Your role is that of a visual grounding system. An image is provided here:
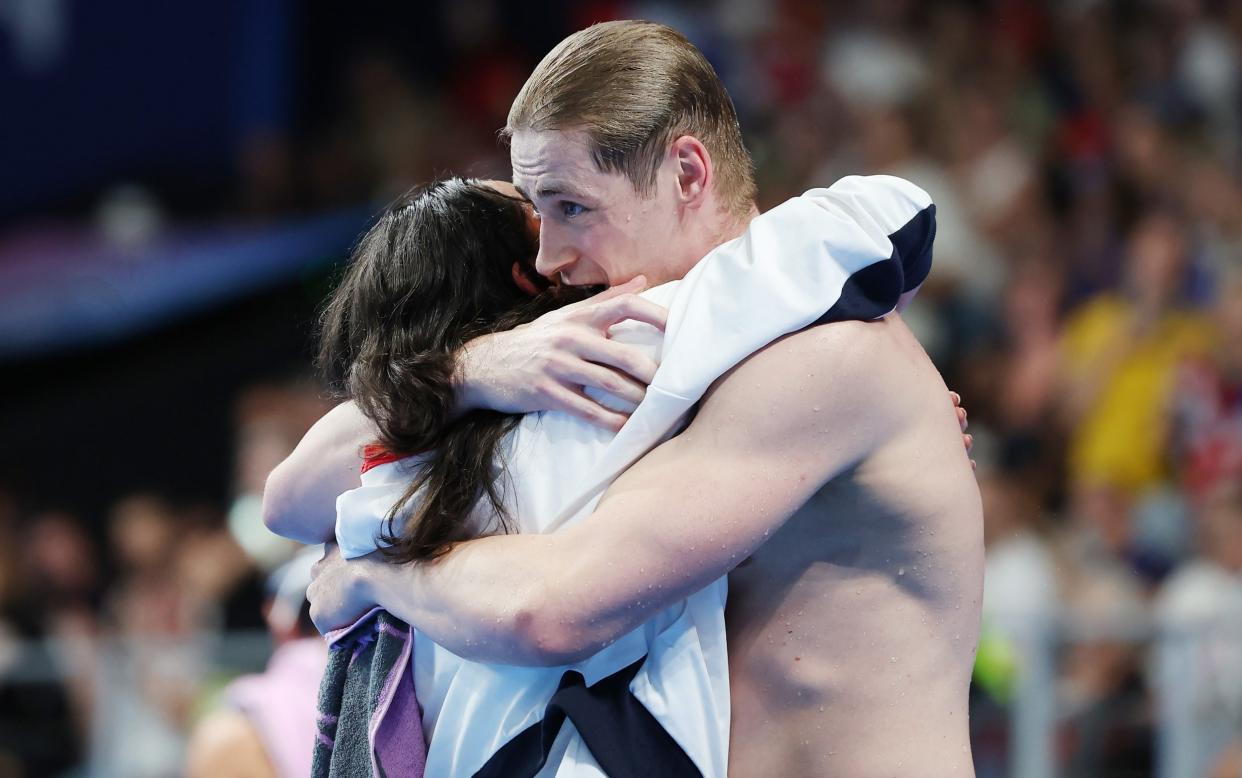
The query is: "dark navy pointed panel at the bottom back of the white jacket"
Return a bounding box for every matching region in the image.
[474,656,703,778]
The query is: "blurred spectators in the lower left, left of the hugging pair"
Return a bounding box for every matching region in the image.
[0,385,328,778]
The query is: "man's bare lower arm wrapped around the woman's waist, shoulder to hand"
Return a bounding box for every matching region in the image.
[311,322,914,665]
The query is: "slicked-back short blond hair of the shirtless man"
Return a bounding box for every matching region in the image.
[504,21,755,214]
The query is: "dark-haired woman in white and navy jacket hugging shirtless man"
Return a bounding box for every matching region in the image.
[288,176,930,777]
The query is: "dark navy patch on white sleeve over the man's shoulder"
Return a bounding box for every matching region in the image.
[815,204,935,324]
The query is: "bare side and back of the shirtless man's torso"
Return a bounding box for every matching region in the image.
[727,317,984,778]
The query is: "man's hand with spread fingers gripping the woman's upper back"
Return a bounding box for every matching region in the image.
[457,276,668,430]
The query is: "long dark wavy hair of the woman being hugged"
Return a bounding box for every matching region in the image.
[319,178,587,562]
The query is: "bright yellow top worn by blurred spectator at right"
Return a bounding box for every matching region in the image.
[1062,295,1211,493]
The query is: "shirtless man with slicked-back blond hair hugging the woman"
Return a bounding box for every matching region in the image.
[285,22,982,777]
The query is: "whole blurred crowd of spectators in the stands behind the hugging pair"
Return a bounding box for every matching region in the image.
[0,0,1242,777]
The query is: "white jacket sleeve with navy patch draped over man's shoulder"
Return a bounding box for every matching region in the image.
[652,175,935,401]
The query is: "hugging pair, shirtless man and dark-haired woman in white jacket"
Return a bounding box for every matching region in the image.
[265,22,982,778]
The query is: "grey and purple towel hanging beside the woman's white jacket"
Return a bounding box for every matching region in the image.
[311,608,427,778]
